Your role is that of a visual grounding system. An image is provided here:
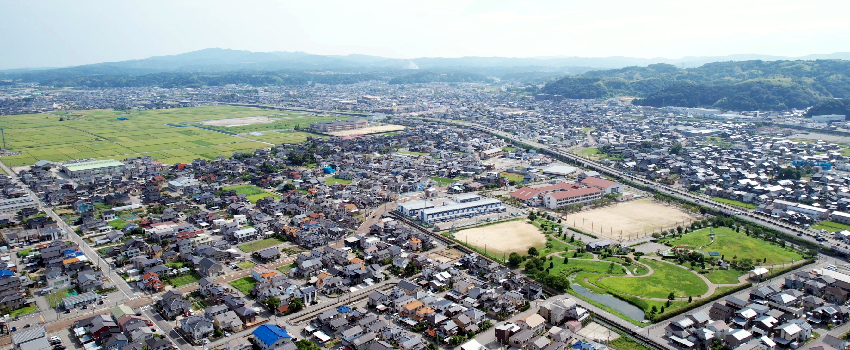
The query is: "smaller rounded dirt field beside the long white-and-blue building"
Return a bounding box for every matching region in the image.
[455,220,546,254]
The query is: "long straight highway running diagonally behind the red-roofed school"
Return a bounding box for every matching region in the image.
[416,117,850,255]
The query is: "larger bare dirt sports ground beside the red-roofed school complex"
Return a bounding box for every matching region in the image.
[566,199,692,239]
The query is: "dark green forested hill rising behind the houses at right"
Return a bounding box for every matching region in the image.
[543,60,850,110]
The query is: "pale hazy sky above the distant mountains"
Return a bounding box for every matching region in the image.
[0,0,850,69]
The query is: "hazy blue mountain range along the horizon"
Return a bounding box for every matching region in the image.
[0,48,850,75]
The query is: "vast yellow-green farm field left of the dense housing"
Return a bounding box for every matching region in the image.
[0,106,318,166]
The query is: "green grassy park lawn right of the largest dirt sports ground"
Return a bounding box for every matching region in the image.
[669,227,803,265]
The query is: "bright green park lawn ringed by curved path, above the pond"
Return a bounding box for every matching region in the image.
[598,259,708,298]
